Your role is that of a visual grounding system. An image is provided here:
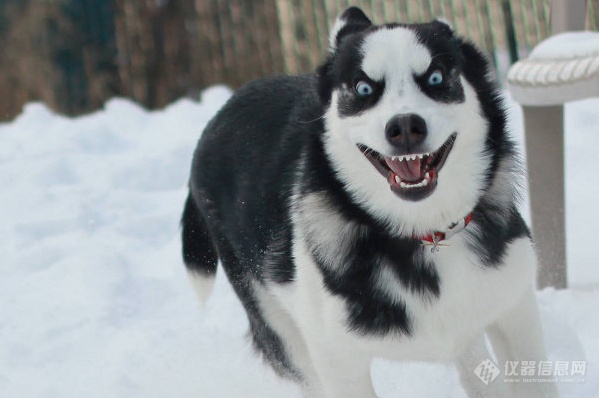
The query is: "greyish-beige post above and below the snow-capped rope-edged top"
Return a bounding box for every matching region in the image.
[523,0,587,289]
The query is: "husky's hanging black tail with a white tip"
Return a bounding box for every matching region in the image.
[181,193,219,307]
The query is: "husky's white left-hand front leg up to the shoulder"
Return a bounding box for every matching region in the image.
[260,215,375,398]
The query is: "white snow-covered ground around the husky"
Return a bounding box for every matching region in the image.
[0,87,598,398]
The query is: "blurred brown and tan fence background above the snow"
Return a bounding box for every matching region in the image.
[0,0,598,121]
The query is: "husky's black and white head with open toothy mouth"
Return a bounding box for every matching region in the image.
[317,7,510,233]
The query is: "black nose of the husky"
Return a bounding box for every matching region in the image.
[385,113,427,153]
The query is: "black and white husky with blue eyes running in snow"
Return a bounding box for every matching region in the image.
[182,8,556,398]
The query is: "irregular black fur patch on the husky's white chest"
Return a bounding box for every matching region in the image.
[313,226,440,336]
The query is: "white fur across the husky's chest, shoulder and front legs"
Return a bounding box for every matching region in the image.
[255,194,556,398]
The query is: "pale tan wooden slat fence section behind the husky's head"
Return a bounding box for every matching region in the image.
[278,0,549,73]
